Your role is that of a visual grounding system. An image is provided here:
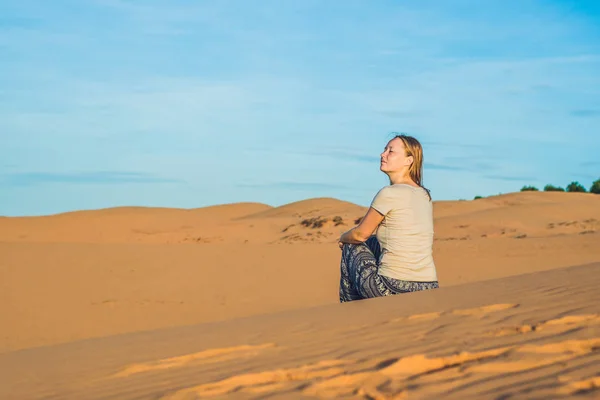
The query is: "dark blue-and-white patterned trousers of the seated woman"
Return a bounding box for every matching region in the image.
[340,236,439,303]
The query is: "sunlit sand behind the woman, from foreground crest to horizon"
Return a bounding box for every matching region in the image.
[0,193,600,352]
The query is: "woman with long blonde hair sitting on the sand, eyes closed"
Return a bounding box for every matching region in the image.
[339,135,439,303]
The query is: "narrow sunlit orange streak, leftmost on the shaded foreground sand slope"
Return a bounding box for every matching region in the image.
[113,343,275,378]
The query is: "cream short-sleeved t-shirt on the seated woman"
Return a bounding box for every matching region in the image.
[371,183,437,282]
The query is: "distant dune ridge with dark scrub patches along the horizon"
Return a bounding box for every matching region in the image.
[0,192,600,244]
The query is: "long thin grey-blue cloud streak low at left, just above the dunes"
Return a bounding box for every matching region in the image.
[0,171,183,186]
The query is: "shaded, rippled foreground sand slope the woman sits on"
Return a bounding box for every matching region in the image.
[0,264,600,400]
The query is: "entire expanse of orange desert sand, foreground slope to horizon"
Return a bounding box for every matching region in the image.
[0,192,600,399]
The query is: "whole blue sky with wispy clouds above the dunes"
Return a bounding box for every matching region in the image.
[0,0,600,215]
